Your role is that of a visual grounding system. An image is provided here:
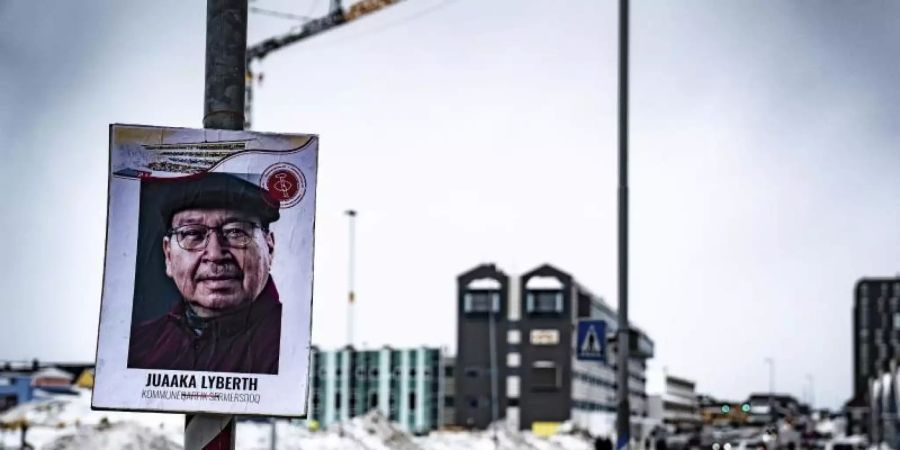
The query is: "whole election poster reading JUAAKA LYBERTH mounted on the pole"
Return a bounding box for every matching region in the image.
[91,124,318,417]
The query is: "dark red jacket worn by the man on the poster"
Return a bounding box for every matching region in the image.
[128,278,281,374]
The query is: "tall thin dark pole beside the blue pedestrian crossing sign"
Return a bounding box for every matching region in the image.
[616,0,631,449]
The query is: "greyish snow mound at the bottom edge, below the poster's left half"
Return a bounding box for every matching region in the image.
[41,422,182,450]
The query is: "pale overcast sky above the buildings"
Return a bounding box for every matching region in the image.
[0,0,900,407]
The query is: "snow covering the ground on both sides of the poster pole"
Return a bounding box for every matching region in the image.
[0,389,593,450]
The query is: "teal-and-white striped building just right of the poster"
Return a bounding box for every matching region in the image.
[309,347,443,433]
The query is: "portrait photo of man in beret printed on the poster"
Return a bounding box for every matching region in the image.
[128,172,282,374]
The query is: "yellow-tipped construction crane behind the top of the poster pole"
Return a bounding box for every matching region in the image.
[244,0,403,130]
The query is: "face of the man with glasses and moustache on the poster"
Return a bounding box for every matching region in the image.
[163,209,275,317]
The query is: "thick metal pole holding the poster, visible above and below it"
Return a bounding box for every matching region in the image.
[184,0,247,450]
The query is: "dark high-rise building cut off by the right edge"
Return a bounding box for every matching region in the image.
[845,276,900,434]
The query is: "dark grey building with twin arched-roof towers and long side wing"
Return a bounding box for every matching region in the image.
[455,265,653,436]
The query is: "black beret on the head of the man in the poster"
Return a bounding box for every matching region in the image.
[160,172,280,226]
